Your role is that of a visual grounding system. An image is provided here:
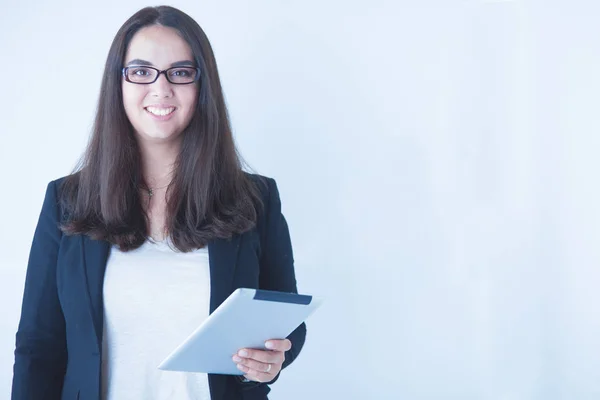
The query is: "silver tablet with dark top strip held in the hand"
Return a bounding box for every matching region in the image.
[158,289,322,375]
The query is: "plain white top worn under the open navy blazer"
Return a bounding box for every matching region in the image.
[102,241,210,400]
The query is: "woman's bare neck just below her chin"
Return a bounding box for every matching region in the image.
[139,141,180,188]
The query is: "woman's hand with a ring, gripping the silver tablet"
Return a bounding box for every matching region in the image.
[233,339,292,382]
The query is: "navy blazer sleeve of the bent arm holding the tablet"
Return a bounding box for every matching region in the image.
[259,178,306,383]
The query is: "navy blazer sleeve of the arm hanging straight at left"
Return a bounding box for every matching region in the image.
[12,182,67,400]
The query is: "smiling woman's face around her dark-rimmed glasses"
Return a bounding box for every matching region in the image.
[122,25,198,143]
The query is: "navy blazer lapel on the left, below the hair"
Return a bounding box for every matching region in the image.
[81,235,110,351]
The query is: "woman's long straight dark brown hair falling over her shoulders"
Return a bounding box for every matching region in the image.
[61,6,261,252]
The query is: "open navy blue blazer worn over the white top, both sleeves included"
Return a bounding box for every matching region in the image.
[12,175,306,400]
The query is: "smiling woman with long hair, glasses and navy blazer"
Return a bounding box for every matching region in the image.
[12,7,306,400]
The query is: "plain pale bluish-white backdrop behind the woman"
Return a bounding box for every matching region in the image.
[0,0,600,400]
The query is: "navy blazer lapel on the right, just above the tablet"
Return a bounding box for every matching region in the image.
[208,234,241,314]
